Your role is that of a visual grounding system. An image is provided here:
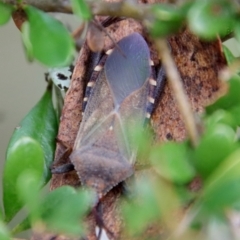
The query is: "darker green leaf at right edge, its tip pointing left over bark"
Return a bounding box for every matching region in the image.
[206,76,240,114]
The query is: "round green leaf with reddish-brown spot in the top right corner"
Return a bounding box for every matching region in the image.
[188,0,235,39]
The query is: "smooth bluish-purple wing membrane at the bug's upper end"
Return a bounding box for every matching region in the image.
[105,33,151,106]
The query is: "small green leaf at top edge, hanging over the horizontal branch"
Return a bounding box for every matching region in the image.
[71,0,92,21]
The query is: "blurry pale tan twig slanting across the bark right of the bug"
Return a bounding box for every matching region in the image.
[154,39,199,146]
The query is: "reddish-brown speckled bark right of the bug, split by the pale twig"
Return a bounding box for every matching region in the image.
[151,29,226,141]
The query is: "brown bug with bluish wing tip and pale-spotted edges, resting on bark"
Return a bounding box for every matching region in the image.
[67,33,164,198]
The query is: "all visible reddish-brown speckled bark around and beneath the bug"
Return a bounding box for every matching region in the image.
[33,1,226,240]
